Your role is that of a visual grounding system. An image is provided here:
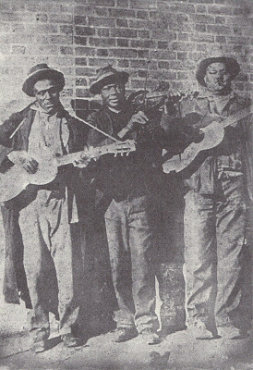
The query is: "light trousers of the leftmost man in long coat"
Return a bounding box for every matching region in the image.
[19,189,79,337]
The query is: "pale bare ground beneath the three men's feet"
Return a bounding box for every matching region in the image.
[0,303,253,370]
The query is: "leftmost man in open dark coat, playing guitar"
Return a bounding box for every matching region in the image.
[0,64,91,352]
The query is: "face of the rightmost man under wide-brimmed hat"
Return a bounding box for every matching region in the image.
[204,63,231,94]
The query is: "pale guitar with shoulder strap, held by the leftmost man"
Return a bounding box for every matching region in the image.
[0,140,136,202]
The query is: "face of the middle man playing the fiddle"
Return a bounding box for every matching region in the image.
[101,83,125,109]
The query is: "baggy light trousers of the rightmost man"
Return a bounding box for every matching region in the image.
[184,172,246,327]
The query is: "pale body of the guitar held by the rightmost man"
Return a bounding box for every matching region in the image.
[162,122,224,173]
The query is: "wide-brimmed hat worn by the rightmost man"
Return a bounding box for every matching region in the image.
[196,57,240,86]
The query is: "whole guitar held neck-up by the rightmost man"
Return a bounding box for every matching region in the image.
[162,104,253,173]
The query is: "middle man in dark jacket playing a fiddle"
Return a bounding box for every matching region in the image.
[88,66,197,344]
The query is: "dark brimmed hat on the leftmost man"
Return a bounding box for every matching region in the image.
[22,64,65,96]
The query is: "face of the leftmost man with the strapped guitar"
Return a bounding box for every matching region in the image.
[34,79,60,113]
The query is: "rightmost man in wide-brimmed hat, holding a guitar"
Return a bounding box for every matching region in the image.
[165,57,253,338]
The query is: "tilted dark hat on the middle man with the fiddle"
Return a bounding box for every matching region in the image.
[90,65,129,94]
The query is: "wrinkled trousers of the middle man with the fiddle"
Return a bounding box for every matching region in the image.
[105,196,158,333]
